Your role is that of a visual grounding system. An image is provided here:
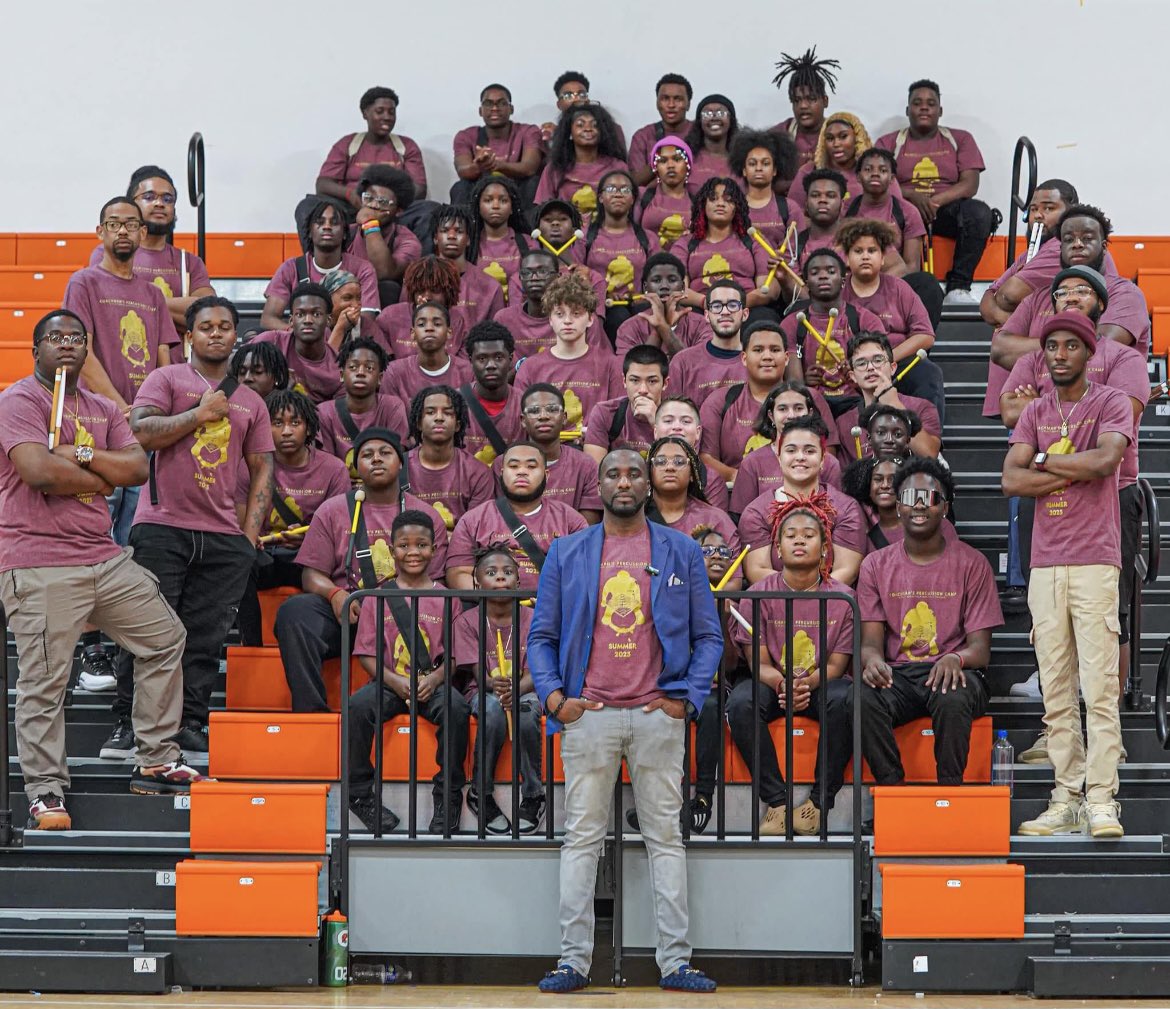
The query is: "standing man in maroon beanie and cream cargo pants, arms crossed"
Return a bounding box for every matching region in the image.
[1003,311,1134,837]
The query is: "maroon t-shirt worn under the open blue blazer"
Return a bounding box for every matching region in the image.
[581,528,663,718]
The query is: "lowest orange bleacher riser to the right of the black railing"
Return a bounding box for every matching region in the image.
[881,863,1024,939]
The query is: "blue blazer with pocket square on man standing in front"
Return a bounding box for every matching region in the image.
[528,522,723,733]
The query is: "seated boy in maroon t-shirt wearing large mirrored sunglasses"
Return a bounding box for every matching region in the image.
[849,458,1004,785]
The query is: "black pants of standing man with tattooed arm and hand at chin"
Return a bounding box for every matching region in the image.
[113,522,256,726]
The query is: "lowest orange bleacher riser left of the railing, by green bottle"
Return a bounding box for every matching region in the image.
[174,858,321,938]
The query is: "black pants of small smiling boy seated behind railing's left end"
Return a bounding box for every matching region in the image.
[350,684,472,800]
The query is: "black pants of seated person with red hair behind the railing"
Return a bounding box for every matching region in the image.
[728,677,853,812]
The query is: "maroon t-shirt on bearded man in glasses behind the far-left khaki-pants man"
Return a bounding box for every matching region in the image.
[61,266,179,403]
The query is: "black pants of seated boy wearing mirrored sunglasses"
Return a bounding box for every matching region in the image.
[849,663,987,784]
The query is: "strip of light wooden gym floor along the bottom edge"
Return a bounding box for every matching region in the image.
[0,984,1156,1009]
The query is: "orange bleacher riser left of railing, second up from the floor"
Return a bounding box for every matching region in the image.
[191,781,329,854]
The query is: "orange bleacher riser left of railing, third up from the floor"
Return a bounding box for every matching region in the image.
[208,712,342,781]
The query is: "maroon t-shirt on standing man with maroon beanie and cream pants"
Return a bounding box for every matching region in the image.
[1007,383,1134,568]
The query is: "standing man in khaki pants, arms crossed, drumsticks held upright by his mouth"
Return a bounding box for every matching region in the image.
[0,309,200,830]
